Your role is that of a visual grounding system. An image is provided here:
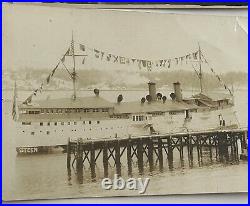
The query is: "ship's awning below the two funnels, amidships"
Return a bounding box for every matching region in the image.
[114,100,198,114]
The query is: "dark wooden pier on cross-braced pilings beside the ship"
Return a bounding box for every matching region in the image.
[67,129,247,180]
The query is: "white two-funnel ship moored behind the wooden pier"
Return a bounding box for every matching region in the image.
[13,37,239,154]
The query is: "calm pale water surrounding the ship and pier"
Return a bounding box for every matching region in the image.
[2,90,248,200]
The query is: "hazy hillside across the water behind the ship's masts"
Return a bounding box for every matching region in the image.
[2,69,247,90]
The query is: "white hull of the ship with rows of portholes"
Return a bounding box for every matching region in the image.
[16,107,238,151]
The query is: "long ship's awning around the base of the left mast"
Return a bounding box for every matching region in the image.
[20,96,113,109]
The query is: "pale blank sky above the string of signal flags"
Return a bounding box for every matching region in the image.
[2,4,248,73]
